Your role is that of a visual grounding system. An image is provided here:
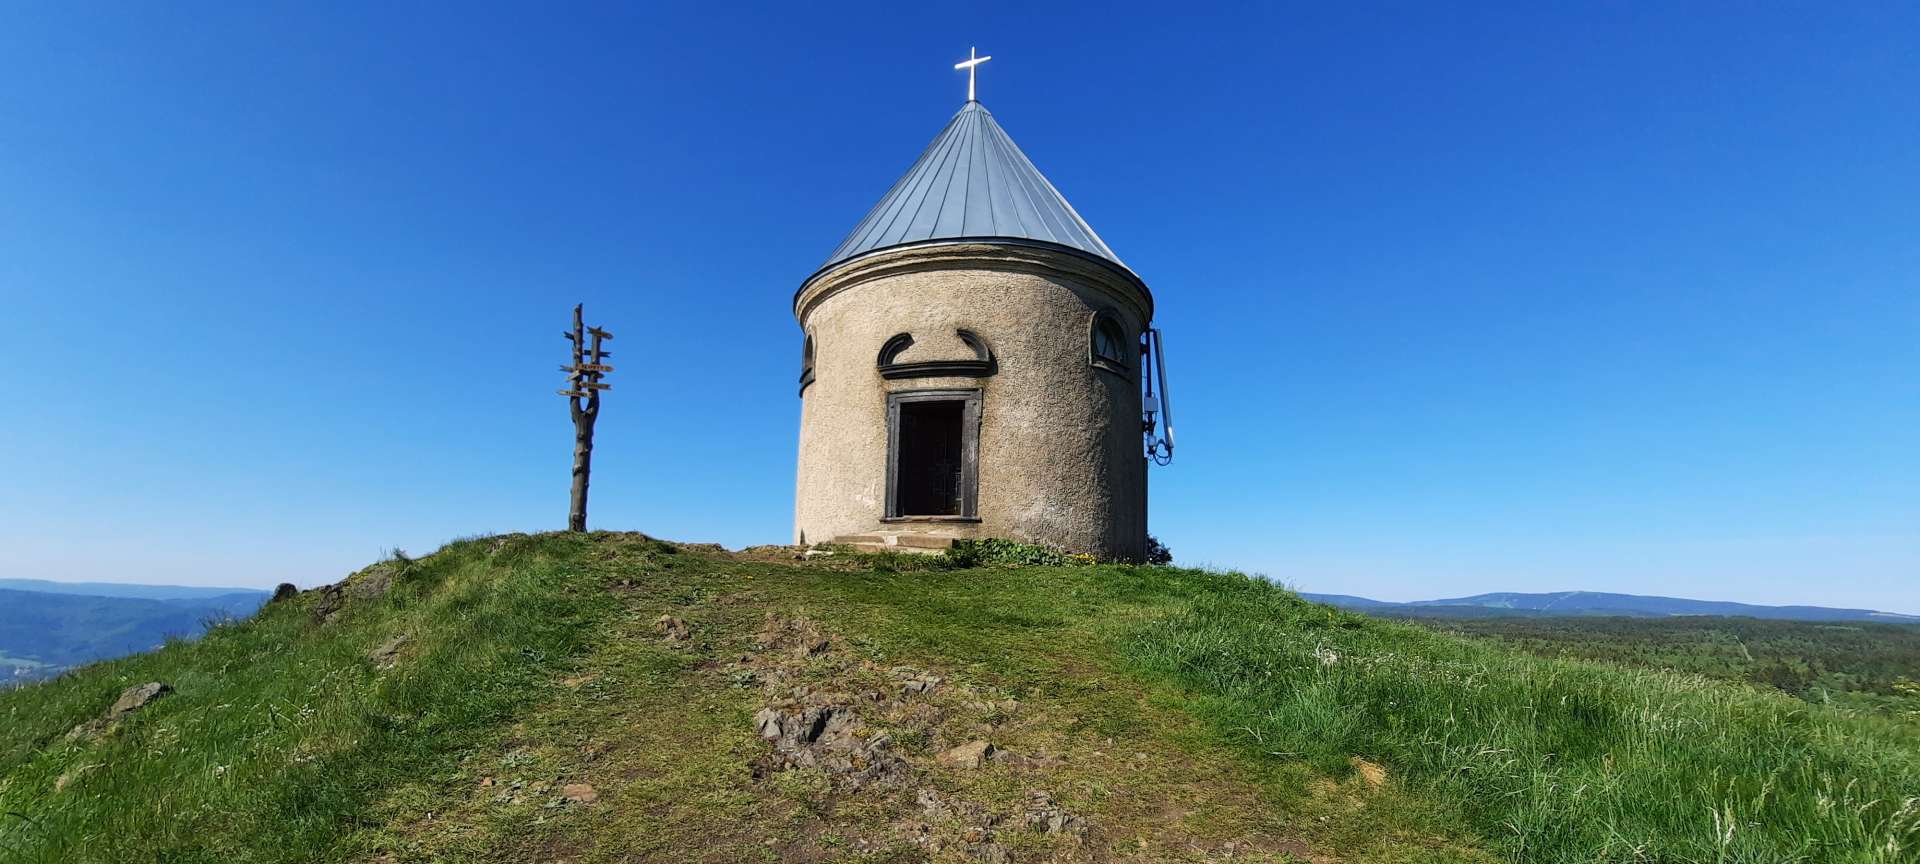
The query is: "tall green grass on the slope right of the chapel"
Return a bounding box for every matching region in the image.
[1129,572,1920,864]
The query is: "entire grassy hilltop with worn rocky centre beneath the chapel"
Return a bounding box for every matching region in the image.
[0,534,1920,862]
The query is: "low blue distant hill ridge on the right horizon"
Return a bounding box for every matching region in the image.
[1302,591,1920,624]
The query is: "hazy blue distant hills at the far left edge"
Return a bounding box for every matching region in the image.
[0,580,269,685]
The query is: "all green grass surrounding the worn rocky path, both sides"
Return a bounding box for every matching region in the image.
[0,534,1920,864]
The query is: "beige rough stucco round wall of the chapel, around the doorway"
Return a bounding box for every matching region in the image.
[795,246,1146,559]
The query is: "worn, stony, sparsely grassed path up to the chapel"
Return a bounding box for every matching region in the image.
[360,543,1443,864]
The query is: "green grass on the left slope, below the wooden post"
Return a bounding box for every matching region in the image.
[0,536,611,862]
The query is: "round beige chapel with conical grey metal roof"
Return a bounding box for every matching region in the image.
[793,81,1164,561]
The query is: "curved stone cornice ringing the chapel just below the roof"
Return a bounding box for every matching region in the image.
[793,240,1154,324]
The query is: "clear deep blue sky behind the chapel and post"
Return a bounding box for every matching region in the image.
[0,4,1920,612]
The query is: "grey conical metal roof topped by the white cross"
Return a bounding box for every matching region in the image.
[820,102,1133,275]
